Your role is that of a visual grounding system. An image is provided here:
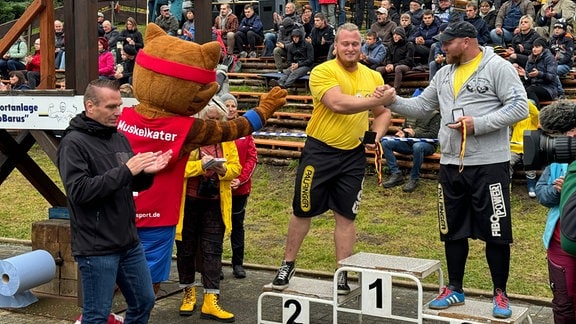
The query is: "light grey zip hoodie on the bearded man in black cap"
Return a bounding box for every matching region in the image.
[389,47,528,165]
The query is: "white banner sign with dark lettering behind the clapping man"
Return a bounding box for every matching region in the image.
[0,95,137,130]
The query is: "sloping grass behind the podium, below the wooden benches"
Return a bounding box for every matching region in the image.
[0,146,551,297]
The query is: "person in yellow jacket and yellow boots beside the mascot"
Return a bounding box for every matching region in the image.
[176,99,242,322]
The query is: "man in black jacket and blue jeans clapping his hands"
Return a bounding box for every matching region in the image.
[58,80,172,323]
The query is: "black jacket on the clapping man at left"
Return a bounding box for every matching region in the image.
[58,112,154,256]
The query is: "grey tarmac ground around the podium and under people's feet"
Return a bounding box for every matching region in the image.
[0,243,554,324]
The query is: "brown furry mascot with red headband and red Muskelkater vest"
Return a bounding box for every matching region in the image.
[118,23,287,306]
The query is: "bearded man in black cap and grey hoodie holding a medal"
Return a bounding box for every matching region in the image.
[382,22,528,318]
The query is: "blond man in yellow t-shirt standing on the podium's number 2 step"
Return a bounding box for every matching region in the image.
[272,23,396,294]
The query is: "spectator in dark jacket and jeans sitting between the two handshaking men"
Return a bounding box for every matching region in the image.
[382,111,441,192]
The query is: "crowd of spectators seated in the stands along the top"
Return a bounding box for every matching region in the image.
[0,0,576,101]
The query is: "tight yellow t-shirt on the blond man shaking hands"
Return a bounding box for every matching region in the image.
[306,59,384,150]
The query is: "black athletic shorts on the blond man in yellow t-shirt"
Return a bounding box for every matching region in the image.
[292,137,366,220]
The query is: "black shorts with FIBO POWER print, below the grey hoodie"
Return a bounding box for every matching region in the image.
[438,162,512,243]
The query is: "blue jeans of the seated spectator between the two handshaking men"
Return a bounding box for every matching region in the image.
[382,140,436,180]
